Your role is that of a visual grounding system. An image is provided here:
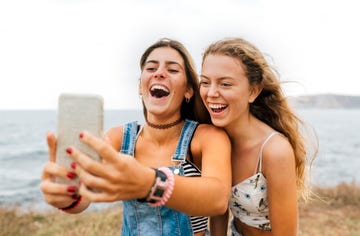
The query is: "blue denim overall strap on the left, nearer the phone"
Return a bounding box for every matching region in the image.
[120,121,139,156]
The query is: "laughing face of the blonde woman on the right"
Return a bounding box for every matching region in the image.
[200,54,257,128]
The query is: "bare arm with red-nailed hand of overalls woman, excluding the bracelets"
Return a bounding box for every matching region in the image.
[70,125,231,215]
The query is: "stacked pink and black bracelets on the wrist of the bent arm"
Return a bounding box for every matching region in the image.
[146,167,175,207]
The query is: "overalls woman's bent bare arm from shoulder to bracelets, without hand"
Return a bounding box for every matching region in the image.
[167,125,231,215]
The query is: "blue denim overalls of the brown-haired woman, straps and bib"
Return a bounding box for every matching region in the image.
[121,120,197,236]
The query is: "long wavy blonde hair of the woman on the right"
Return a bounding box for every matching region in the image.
[203,38,317,200]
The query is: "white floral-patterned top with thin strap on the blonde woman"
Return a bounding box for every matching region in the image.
[229,131,279,231]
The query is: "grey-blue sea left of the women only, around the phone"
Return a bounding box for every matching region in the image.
[0,110,144,209]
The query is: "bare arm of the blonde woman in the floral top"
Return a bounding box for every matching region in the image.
[263,136,298,235]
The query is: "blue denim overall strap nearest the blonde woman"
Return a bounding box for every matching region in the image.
[171,119,198,162]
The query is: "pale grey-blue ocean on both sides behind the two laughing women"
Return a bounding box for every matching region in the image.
[0,109,360,206]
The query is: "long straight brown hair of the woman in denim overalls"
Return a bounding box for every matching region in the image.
[140,38,211,124]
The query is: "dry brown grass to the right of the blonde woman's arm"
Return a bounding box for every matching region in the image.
[299,183,360,236]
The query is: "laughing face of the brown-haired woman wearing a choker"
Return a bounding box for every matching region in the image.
[139,47,192,120]
